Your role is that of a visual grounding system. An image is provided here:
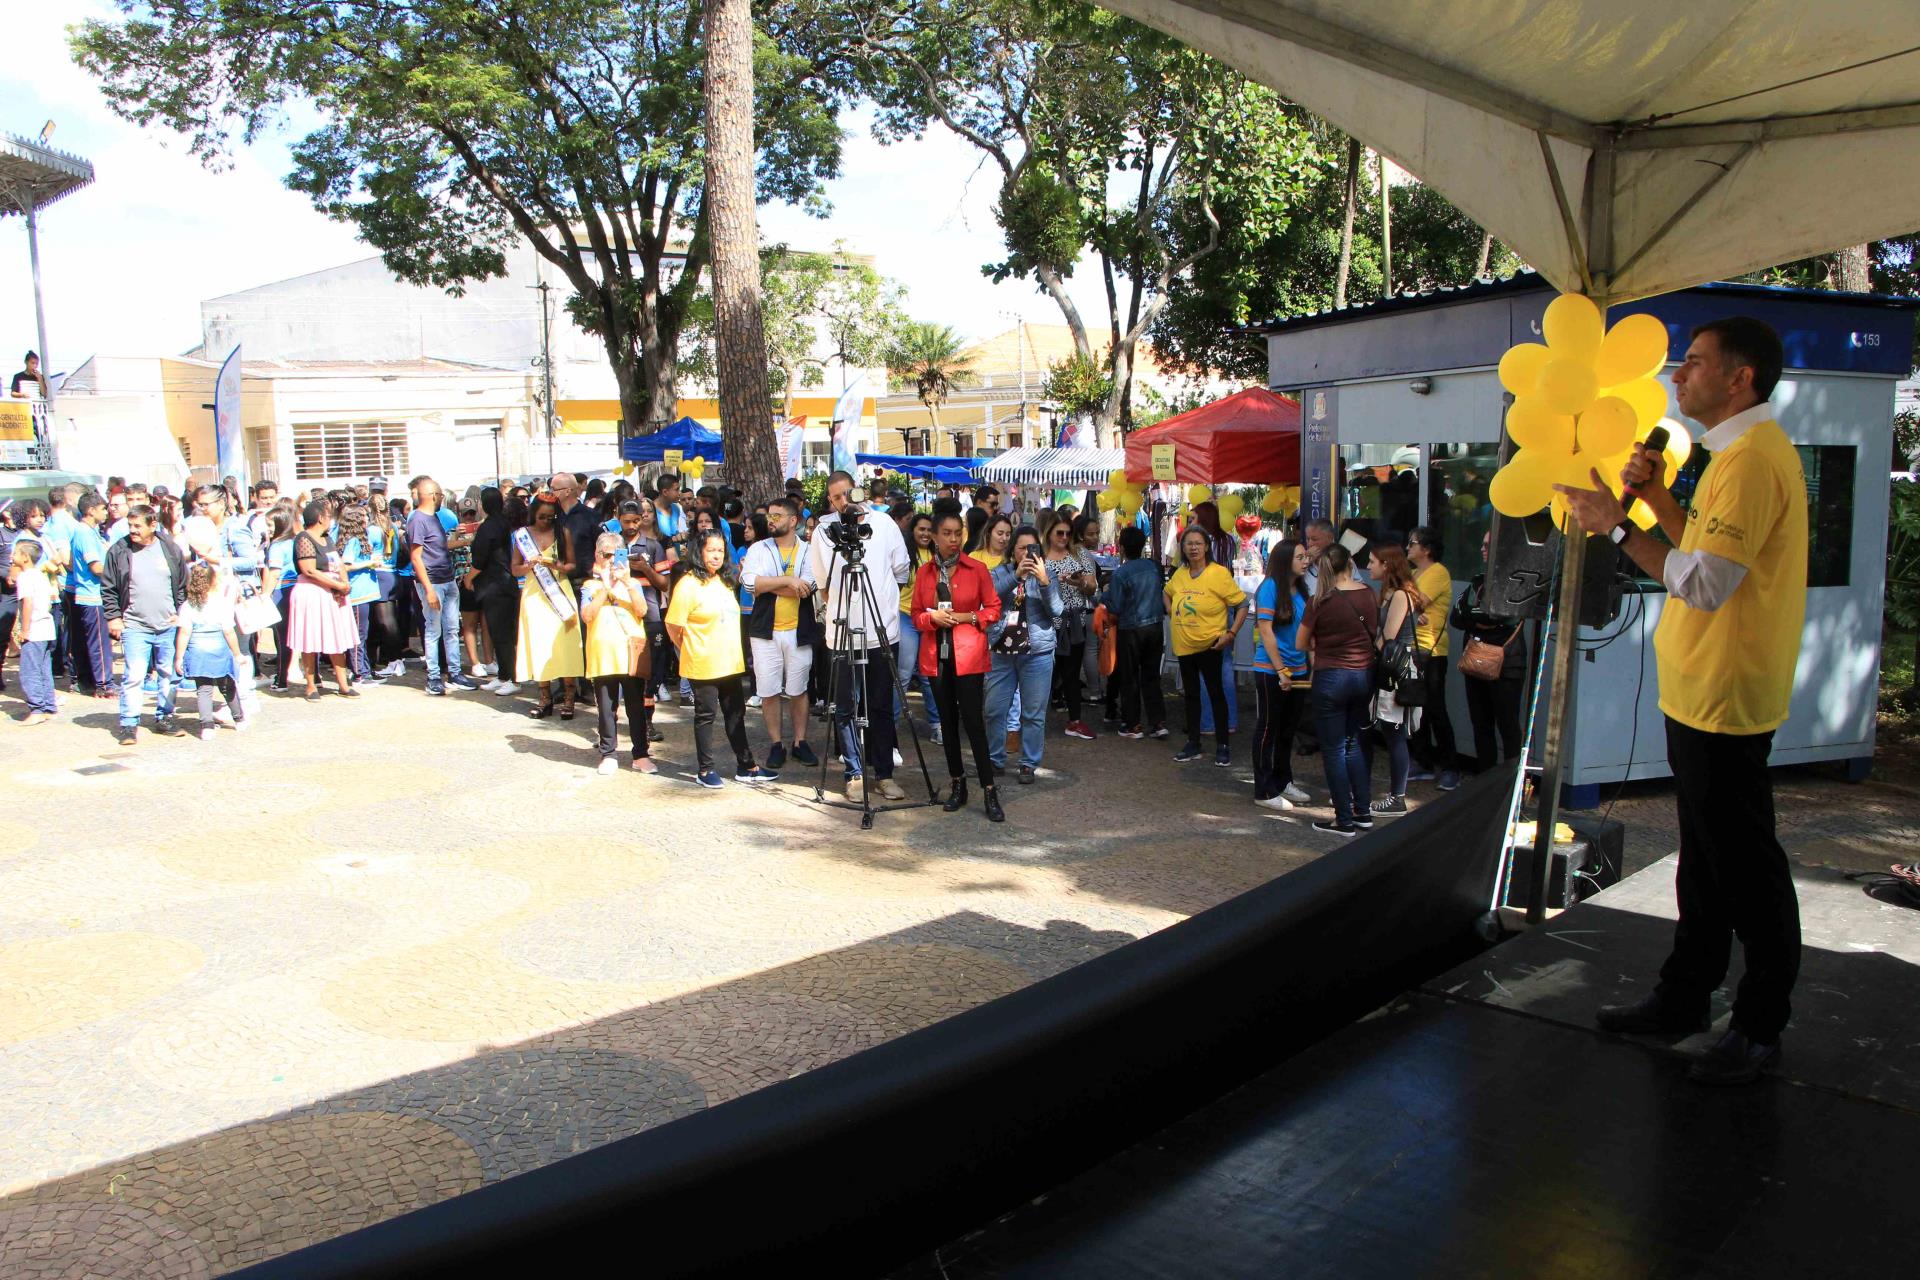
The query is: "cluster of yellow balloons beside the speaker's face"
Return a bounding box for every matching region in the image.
[1488,294,1693,528]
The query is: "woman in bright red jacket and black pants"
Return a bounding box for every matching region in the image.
[912,497,1006,821]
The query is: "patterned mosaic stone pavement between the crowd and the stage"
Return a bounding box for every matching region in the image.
[0,687,1912,1278]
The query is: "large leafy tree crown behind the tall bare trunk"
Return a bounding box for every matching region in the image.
[71,0,860,429]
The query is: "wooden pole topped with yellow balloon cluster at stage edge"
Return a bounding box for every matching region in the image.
[1488,294,1693,925]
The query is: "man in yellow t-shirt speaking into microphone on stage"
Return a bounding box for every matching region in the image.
[1559,317,1807,1084]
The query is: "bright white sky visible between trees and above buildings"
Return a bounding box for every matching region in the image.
[0,0,1106,370]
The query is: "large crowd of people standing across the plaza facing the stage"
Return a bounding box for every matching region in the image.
[0,472,1528,835]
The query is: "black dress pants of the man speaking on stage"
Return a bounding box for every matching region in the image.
[1659,720,1801,1044]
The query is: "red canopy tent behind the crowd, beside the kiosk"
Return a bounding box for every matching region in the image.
[1127,388,1300,484]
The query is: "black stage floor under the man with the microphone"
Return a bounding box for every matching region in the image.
[899,860,1920,1280]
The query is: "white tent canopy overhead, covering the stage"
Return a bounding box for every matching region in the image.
[1102,0,1920,301]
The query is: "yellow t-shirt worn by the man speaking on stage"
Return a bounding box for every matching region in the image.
[1653,420,1807,733]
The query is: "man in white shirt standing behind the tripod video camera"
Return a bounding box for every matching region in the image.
[808,470,910,802]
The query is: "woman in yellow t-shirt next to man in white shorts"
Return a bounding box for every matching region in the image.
[664,528,780,791]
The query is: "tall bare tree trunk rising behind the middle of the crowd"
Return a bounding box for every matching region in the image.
[705,0,781,503]
